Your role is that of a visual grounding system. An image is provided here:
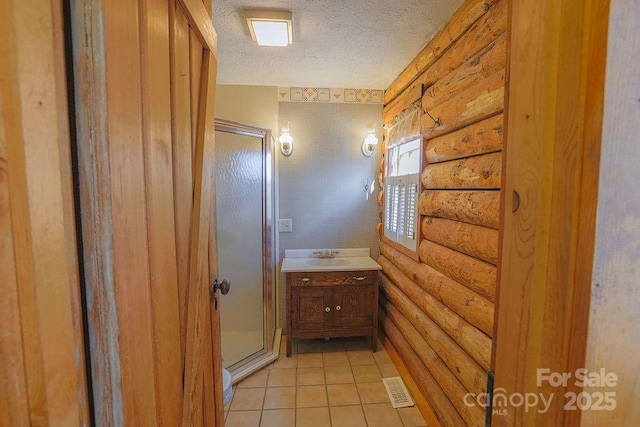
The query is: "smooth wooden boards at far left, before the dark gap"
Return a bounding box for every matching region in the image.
[0,0,90,426]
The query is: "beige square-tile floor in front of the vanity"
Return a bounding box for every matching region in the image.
[225,338,426,427]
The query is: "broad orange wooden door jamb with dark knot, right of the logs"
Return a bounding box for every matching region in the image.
[493,0,608,426]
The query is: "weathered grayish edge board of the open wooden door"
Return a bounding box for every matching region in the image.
[71,2,124,425]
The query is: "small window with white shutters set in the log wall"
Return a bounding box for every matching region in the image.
[384,137,422,251]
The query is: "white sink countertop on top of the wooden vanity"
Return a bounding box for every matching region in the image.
[281,248,382,273]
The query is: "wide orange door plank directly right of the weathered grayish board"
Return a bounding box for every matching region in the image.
[104,1,159,425]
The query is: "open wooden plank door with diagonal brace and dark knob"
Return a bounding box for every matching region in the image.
[70,0,223,426]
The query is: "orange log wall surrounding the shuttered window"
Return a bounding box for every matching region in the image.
[378,0,507,425]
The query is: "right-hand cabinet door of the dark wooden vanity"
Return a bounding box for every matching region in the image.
[332,286,373,328]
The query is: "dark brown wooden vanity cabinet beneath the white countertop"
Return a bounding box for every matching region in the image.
[286,270,378,356]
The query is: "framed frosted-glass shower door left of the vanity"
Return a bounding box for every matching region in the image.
[215,119,279,382]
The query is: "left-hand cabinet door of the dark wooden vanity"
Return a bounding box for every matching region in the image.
[291,287,331,331]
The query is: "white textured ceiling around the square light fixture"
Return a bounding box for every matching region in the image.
[213,0,462,89]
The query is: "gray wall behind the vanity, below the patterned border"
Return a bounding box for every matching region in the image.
[274,102,382,325]
